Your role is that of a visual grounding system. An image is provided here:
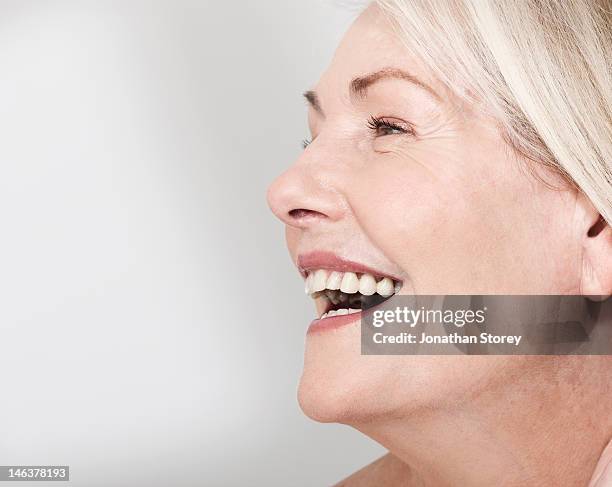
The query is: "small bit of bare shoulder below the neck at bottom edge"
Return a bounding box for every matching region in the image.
[334,453,412,487]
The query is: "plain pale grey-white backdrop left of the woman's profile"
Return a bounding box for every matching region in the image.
[0,0,382,487]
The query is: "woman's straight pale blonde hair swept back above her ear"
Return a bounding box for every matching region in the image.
[375,0,612,224]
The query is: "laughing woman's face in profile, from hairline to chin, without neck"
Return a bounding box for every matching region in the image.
[269,6,580,422]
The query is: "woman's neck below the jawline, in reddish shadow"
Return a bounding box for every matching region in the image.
[353,356,612,487]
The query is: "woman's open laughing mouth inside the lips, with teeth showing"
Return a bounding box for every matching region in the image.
[305,269,402,320]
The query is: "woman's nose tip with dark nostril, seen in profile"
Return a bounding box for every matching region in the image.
[267,161,346,229]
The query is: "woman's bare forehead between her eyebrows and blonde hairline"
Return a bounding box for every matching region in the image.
[316,4,436,98]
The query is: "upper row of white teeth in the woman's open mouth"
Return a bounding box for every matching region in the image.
[304,269,399,297]
